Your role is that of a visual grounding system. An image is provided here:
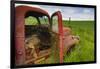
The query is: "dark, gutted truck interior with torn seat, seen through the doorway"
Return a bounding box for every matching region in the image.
[25,11,52,64]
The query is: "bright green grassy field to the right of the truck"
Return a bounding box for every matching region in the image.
[63,21,94,62]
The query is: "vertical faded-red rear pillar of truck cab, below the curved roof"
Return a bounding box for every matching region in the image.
[15,11,25,65]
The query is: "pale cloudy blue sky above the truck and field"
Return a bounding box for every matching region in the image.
[17,4,94,20]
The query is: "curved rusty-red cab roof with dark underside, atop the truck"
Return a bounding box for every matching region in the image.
[15,5,49,17]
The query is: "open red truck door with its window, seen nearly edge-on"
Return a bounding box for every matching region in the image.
[51,11,63,63]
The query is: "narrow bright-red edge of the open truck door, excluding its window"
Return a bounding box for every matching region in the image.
[52,11,63,63]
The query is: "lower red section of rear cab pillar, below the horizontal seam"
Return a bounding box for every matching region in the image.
[16,37,25,65]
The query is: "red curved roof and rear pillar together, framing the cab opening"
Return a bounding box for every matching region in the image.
[15,6,50,65]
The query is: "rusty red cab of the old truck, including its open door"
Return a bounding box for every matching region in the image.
[15,6,78,65]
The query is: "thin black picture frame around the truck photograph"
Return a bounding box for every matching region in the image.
[10,1,96,68]
